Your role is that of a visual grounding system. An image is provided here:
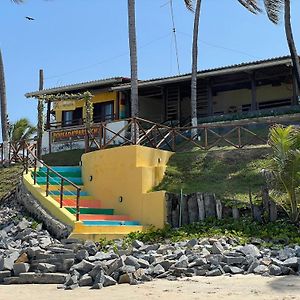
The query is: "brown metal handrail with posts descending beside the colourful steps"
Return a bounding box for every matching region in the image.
[24,142,81,221]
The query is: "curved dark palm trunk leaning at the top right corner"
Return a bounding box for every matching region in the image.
[284,0,300,92]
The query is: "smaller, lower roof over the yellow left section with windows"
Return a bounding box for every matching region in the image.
[25,77,129,98]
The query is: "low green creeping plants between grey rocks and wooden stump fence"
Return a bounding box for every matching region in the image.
[99,218,300,250]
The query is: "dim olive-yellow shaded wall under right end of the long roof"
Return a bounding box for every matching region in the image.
[213,83,293,114]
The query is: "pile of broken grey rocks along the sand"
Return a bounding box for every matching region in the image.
[0,214,300,289]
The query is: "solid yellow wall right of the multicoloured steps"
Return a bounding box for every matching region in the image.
[82,146,173,228]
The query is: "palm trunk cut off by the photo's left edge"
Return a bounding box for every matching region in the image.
[0,50,8,142]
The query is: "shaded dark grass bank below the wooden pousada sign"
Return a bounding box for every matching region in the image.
[42,149,84,166]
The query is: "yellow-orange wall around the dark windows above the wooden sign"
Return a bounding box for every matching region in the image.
[53,91,118,122]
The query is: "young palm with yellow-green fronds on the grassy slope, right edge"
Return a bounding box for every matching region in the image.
[269,125,300,222]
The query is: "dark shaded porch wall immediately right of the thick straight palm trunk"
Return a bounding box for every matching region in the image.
[139,97,165,123]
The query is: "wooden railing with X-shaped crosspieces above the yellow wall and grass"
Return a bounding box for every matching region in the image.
[87,118,274,151]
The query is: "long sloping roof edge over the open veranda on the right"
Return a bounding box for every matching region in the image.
[112,56,292,91]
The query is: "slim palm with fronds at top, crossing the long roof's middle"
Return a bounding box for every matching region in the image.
[184,0,260,132]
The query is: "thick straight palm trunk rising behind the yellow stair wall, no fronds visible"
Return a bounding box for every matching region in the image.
[128,0,139,144]
